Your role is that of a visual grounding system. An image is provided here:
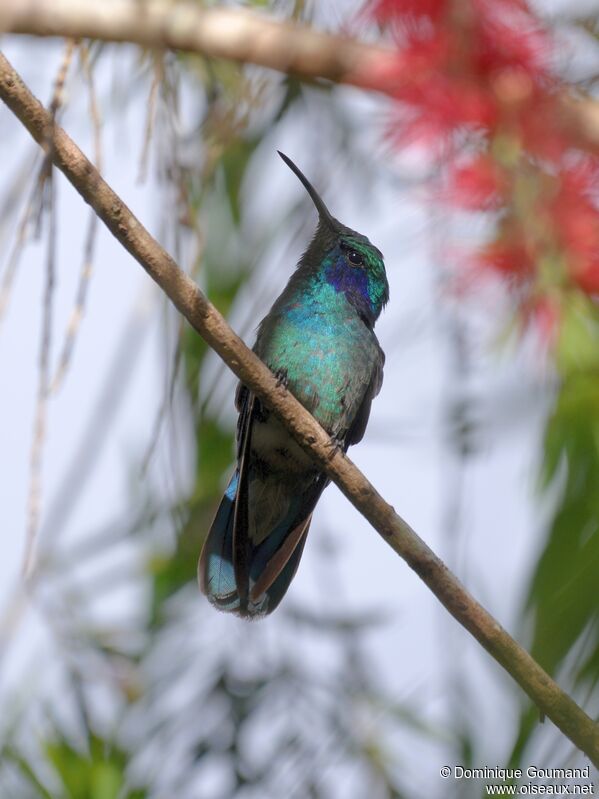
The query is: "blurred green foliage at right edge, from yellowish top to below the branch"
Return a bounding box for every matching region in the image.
[510,296,599,766]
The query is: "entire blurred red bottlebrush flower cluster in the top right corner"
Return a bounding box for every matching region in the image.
[366,0,599,334]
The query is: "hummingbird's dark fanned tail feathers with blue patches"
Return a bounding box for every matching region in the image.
[198,471,327,617]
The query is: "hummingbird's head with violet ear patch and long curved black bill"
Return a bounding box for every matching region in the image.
[278,151,389,327]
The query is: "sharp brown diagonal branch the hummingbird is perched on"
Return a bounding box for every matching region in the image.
[0,54,599,766]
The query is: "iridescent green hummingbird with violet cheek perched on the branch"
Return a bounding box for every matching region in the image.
[198,152,389,618]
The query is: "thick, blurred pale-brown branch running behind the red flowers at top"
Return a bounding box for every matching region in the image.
[0,0,599,147]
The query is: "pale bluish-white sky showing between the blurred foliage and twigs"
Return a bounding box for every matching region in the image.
[0,12,596,798]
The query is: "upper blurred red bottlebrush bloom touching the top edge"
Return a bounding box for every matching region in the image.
[361,0,547,146]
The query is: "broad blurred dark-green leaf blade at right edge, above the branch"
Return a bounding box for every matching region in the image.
[528,372,599,673]
